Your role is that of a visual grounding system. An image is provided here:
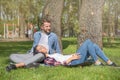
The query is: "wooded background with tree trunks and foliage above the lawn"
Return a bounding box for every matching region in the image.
[0,0,120,47]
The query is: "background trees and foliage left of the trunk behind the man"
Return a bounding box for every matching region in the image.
[0,0,44,38]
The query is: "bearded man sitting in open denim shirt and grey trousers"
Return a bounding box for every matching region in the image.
[6,19,61,71]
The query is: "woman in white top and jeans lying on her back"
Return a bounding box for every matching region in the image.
[36,39,116,66]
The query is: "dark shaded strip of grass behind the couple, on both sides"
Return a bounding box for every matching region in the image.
[0,38,120,57]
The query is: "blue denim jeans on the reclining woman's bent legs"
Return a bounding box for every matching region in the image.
[70,39,108,65]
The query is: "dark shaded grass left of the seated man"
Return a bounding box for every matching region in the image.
[0,41,32,57]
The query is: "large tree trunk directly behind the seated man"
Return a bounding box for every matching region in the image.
[42,0,64,50]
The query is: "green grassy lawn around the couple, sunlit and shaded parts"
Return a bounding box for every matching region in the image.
[0,38,120,80]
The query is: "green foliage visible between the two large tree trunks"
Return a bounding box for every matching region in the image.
[62,0,79,37]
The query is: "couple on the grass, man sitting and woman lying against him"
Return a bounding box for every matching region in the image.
[6,19,116,71]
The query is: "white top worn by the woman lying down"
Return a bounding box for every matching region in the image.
[48,53,72,64]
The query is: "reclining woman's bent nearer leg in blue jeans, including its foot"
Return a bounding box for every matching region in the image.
[71,39,101,65]
